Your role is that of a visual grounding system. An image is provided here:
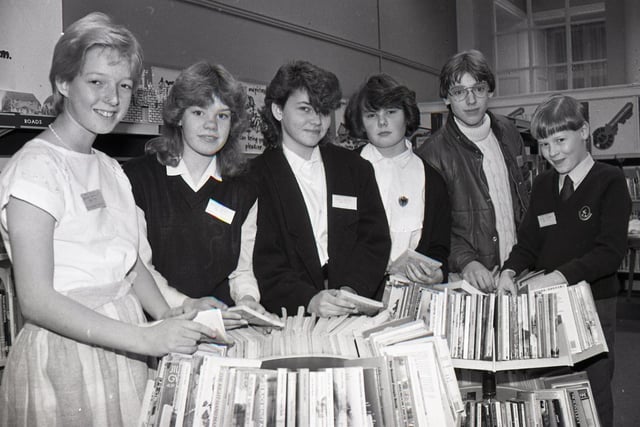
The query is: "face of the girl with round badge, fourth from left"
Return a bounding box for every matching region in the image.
[362,108,407,157]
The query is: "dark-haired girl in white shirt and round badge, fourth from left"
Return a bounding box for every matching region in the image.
[345,74,451,285]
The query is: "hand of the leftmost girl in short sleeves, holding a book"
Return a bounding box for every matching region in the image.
[140,311,218,357]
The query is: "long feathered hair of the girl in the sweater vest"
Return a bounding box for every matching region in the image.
[145,61,249,176]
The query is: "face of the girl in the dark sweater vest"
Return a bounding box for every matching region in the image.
[180,96,231,161]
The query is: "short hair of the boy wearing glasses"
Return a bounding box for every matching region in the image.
[440,49,496,99]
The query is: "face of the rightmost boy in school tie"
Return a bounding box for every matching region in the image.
[538,123,589,174]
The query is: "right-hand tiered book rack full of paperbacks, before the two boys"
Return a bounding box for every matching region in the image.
[386,274,608,426]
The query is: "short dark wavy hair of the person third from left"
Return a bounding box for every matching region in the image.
[260,60,342,147]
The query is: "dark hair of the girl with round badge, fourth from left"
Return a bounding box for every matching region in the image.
[344,73,420,139]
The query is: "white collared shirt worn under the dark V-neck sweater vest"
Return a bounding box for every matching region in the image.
[138,156,260,307]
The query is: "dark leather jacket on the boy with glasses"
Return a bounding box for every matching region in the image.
[416,112,531,272]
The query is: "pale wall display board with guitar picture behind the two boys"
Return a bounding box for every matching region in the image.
[419,84,640,159]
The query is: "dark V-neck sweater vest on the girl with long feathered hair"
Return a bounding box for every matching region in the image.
[124,155,256,305]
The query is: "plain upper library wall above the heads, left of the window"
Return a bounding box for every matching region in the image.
[62,0,457,100]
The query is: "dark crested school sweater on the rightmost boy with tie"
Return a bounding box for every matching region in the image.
[504,162,631,299]
